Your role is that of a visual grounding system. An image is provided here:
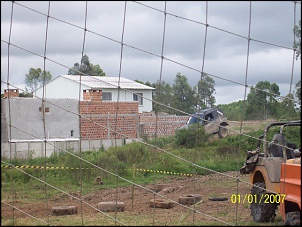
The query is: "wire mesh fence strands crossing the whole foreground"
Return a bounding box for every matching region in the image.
[1,1,300,225]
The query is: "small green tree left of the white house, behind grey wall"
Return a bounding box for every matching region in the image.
[25,68,52,93]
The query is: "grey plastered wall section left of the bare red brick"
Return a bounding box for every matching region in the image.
[1,97,80,141]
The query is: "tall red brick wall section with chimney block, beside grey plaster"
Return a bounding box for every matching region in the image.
[80,90,139,140]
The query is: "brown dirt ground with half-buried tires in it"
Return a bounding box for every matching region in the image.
[1,172,282,226]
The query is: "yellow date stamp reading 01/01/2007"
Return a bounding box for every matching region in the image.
[230,194,286,204]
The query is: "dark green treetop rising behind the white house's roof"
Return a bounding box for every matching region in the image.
[68,54,106,76]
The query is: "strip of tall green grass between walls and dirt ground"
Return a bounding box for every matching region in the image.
[2,129,260,191]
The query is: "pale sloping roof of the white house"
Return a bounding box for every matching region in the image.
[60,75,154,90]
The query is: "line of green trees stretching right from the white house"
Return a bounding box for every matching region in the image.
[145,73,301,121]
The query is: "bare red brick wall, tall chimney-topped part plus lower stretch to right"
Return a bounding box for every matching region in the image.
[80,90,189,140]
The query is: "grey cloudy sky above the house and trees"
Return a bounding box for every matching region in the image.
[1,1,301,104]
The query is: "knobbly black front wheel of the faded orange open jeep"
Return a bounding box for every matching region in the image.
[250,182,277,222]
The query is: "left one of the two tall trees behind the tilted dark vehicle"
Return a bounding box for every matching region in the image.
[171,73,197,114]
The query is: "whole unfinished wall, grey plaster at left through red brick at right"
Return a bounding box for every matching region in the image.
[1,89,188,158]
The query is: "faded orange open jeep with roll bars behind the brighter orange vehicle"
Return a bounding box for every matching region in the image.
[240,120,301,222]
